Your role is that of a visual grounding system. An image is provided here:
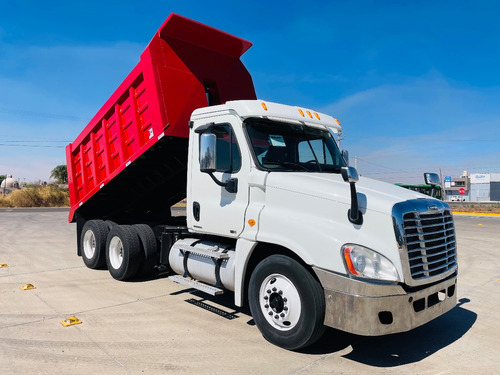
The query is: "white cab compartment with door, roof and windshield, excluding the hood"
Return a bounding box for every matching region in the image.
[187,100,346,239]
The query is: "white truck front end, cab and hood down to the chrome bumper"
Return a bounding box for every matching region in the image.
[177,100,457,347]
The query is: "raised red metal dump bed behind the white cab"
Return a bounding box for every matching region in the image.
[66,14,255,221]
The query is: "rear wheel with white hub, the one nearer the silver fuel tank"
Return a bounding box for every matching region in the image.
[106,225,142,280]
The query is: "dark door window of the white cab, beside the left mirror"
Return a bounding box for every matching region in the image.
[212,124,241,172]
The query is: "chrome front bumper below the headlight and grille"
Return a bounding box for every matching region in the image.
[314,268,457,336]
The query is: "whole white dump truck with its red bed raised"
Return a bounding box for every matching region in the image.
[66,14,458,350]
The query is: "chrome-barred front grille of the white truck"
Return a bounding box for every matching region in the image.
[393,199,458,286]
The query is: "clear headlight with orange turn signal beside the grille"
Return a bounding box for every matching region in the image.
[342,244,399,281]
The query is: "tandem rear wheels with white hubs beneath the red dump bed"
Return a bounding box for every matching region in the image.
[80,220,158,280]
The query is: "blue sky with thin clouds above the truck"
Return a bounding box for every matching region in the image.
[0,0,500,183]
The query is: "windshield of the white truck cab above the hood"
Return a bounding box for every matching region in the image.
[245,119,345,173]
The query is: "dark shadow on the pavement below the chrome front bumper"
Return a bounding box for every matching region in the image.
[302,298,477,367]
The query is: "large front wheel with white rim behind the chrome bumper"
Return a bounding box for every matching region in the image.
[248,255,325,350]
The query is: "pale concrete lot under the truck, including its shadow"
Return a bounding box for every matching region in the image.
[0,210,500,375]
